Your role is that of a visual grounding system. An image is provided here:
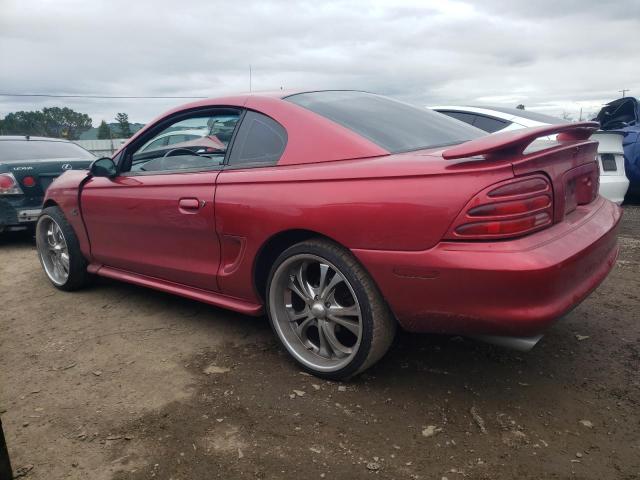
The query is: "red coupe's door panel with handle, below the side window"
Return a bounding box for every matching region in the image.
[81,171,220,290]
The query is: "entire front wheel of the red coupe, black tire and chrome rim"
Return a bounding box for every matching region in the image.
[36,206,89,291]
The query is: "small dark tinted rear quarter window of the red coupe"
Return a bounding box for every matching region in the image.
[229,110,287,166]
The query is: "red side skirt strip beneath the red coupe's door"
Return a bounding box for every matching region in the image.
[87,264,264,317]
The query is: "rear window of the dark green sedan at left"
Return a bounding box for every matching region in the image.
[0,140,95,162]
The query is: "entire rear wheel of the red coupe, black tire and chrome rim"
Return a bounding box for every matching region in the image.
[267,239,396,380]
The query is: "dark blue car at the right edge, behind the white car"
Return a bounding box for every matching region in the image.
[595,97,640,194]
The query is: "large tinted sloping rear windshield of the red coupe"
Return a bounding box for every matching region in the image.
[285,91,486,153]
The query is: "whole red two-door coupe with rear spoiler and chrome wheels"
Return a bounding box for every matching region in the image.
[36,91,620,378]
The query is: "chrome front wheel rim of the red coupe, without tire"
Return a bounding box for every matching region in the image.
[36,216,69,285]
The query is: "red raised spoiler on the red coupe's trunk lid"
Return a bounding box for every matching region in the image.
[442,122,600,160]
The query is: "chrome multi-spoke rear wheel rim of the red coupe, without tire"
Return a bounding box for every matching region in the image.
[269,254,362,372]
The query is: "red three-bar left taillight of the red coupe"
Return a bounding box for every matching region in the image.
[446,175,553,240]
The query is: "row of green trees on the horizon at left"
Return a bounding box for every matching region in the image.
[0,107,132,140]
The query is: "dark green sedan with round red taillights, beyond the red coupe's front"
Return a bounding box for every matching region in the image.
[0,136,96,232]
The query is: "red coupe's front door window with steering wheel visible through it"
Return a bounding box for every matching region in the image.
[127,108,240,174]
